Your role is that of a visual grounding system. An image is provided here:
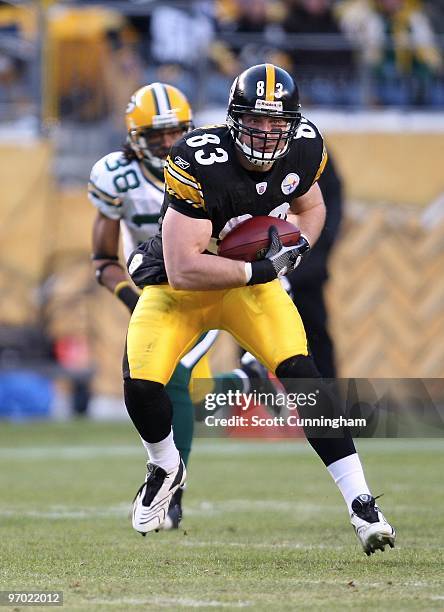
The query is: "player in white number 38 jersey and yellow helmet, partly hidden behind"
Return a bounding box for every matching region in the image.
[88,83,217,528]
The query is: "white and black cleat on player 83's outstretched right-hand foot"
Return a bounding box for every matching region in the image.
[350,494,396,556]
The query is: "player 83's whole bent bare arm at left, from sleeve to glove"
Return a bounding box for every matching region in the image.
[162,208,247,290]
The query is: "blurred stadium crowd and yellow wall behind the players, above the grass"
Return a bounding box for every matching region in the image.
[0,0,444,419]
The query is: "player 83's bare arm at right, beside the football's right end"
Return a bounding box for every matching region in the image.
[287,183,326,246]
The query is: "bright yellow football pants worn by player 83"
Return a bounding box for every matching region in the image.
[127,280,308,384]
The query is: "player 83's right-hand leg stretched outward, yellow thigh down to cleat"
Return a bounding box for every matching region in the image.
[224,281,395,554]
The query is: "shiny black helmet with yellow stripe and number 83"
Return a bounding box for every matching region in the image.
[227,64,301,166]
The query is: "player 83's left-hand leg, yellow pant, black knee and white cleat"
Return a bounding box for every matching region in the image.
[124,285,206,534]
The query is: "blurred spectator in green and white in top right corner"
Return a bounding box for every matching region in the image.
[341,0,444,106]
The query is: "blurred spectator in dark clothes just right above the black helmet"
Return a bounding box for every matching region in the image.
[282,0,359,106]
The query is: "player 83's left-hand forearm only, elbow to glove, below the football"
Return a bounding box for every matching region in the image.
[165,254,247,291]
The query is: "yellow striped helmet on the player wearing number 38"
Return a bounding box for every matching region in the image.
[126,83,193,170]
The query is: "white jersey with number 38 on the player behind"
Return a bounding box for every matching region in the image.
[88,151,164,259]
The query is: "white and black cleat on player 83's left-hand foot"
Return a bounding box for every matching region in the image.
[132,458,187,535]
